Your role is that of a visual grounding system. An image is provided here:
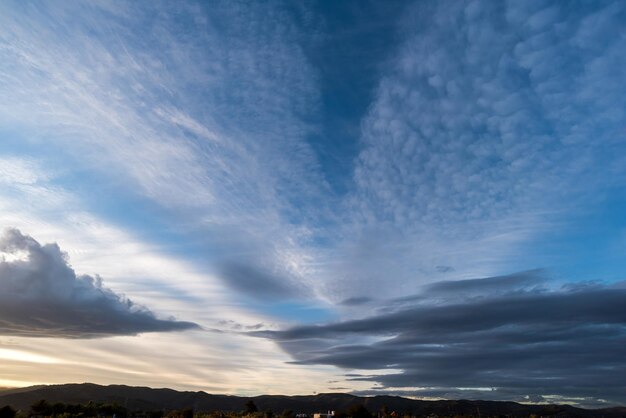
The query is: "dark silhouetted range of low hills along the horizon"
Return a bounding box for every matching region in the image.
[0,383,626,418]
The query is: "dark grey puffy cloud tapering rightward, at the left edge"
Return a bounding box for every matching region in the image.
[0,229,198,338]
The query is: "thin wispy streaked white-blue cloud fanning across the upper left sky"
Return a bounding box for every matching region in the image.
[0,2,328,306]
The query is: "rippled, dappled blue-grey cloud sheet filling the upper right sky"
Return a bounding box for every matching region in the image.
[320,1,626,300]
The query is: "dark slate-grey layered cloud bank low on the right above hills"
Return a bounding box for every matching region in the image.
[255,271,626,405]
